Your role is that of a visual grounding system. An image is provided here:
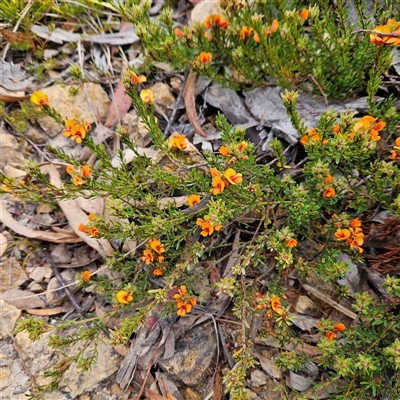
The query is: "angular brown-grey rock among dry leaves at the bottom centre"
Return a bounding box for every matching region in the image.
[159,323,216,386]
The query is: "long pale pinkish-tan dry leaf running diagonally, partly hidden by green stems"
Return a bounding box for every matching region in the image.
[48,165,113,257]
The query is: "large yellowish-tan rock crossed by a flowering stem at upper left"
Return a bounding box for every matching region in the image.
[38,82,110,137]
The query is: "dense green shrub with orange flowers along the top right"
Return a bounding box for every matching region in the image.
[121,0,399,98]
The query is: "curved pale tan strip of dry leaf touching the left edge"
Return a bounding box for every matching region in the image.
[0,203,83,243]
